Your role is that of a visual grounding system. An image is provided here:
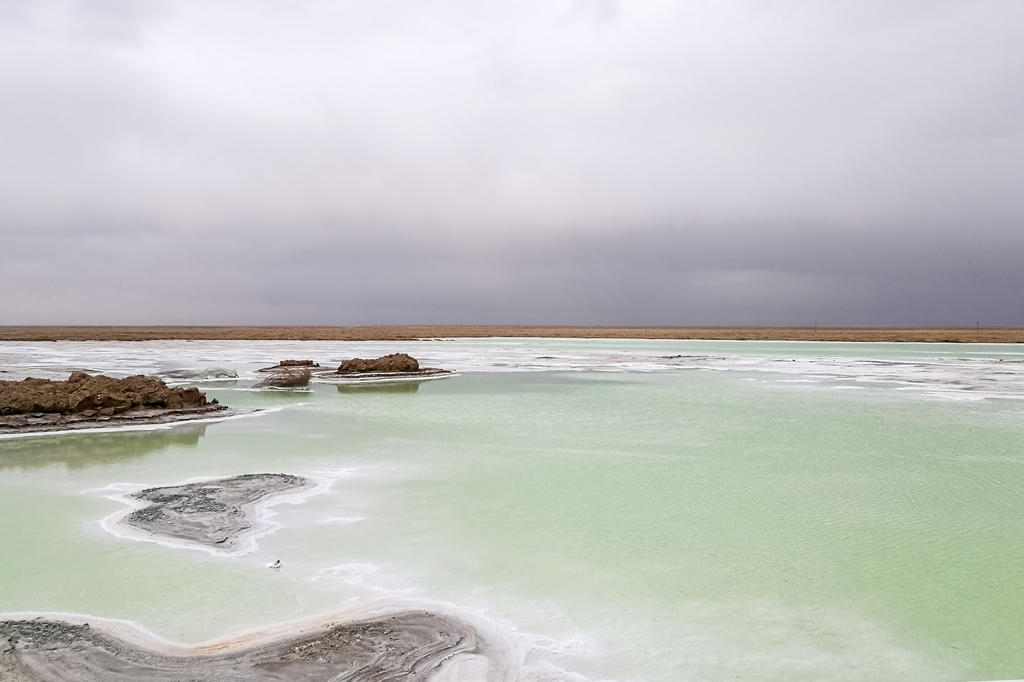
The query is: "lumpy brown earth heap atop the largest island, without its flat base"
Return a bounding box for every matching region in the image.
[0,372,217,417]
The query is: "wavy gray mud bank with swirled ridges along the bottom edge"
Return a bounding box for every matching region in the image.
[0,611,482,682]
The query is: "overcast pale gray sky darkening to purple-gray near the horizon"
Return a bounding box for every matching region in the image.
[0,0,1024,326]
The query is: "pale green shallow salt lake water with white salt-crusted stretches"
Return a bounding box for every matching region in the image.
[0,339,1024,681]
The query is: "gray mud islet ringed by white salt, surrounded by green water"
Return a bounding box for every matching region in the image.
[121,473,312,550]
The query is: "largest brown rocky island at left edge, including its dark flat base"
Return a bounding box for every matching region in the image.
[0,372,238,435]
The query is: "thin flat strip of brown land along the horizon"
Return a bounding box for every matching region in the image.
[0,325,1024,343]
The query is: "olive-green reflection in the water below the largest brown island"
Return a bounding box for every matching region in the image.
[0,424,207,469]
